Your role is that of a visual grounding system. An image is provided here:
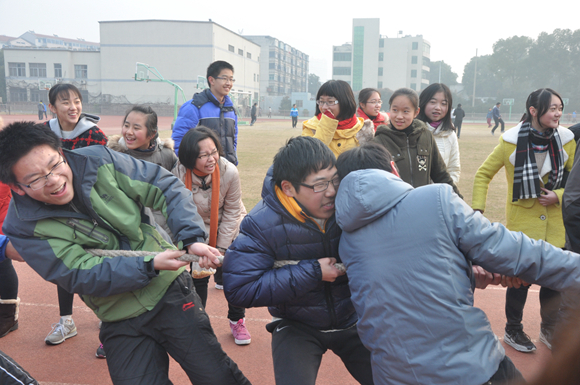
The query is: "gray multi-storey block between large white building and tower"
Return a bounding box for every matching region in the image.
[244,35,308,96]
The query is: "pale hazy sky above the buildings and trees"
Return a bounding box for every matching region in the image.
[0,0,580,81]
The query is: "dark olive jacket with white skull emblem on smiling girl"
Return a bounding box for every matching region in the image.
[373,119,461,197]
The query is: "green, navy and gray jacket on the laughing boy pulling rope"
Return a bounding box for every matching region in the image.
[3,146,207,322]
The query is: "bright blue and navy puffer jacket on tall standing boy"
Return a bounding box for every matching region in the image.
[171,88,238,165]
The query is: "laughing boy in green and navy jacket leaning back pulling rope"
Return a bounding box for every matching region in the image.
[0,122,249,385]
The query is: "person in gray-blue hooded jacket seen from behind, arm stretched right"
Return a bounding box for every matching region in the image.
[336,145,580,385]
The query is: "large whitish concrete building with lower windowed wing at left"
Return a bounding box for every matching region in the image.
[3,20,260,107]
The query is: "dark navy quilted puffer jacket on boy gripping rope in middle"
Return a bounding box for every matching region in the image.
[223,168,357,330]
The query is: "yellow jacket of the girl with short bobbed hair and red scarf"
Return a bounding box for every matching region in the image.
[302,114,364,157]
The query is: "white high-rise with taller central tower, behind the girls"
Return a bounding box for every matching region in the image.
[332,19,431,91]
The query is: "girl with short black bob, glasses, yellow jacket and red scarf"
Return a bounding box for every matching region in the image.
[302,80,374,157]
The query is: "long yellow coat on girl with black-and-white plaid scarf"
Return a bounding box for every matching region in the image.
[471,123,576,247]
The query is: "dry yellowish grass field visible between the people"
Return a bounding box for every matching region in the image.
[162,120,509,224]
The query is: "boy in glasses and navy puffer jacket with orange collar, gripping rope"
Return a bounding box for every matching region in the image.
[223,137,373,385]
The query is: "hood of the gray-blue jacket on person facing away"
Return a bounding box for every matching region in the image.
[336,169,413,232]
